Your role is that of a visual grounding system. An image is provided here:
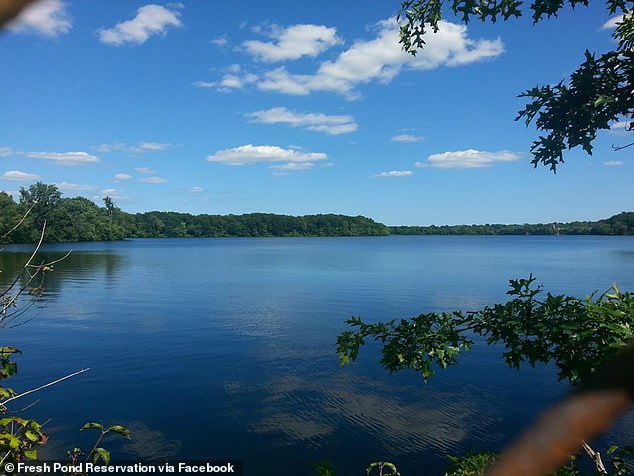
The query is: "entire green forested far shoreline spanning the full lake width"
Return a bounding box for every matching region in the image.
[0,182,634,243]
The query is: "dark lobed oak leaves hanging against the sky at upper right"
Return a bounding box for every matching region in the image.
[398,0,634,171]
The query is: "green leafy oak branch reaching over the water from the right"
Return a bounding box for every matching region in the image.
[337,275,634,384]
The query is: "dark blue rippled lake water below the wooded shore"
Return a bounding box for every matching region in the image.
[0,236,634,475]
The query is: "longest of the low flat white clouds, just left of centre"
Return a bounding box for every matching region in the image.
[207,144,328,175]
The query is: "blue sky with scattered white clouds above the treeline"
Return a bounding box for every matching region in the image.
[0,0,634,225]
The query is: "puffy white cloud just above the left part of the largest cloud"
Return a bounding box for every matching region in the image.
[242,25,342,63]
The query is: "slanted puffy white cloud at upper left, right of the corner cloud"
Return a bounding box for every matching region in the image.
[98,4,183,46]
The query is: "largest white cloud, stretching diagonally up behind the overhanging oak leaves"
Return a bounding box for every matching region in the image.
[210,20,504,99]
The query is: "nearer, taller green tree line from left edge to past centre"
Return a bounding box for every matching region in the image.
[0,182,389,243]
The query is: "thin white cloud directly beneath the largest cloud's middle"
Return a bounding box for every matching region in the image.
[246,107,359,135]
